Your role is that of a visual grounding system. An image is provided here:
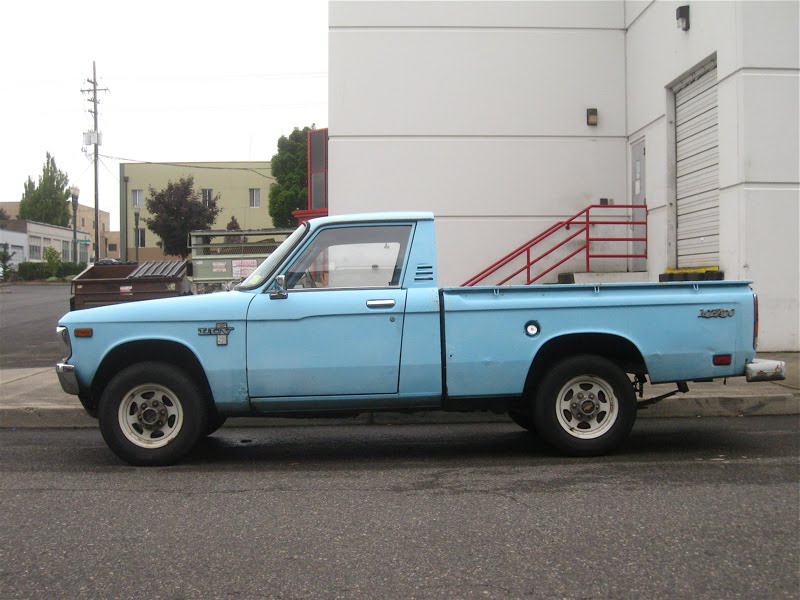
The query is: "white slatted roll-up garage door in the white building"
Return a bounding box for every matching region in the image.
[673,61,719,268]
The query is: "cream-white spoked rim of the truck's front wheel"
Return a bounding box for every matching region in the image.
[118,383,183,449]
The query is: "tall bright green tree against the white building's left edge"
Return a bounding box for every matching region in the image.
[269,125,314,227]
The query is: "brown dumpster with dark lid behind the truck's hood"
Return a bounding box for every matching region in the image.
[69,260,190,310]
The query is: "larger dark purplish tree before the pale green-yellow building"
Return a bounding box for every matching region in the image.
[144,176,222,258]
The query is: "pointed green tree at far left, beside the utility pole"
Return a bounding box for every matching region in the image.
[18,152,69,227]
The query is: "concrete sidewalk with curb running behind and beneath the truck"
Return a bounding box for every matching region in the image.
[0,352,800,428]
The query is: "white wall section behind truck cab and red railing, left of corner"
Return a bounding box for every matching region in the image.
[329,2,626,285]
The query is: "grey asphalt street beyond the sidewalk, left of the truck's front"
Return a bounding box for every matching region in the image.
[0,283,70,369]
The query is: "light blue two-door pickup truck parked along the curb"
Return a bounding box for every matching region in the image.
[56,213,785,465]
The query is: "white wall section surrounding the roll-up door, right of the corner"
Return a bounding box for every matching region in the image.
[625,2,800,350]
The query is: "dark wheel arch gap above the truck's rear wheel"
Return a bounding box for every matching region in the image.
[523,333,647,398]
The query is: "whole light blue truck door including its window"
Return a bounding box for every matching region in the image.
[247,224,412,398]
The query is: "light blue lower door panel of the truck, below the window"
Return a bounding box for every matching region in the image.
[247,288,406,398]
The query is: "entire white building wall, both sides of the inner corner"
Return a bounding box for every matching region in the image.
[329,0,800,350]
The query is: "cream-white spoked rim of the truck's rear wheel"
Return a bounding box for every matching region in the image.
[556,375,619,440]
